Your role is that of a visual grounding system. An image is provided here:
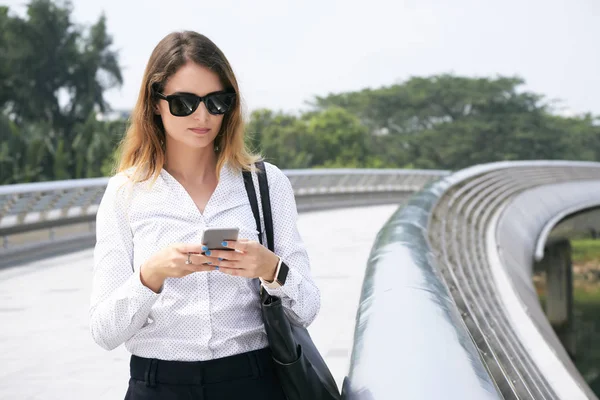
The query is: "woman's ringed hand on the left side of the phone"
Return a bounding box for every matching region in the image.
[140,243,214,293]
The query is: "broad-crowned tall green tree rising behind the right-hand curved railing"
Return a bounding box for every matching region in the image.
[313,75,600,169]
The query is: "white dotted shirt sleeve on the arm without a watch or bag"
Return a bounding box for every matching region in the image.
[89,175,159,350]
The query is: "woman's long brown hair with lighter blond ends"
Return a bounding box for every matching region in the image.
[117,31,260,182]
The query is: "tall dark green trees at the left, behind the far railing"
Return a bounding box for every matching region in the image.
[0,0,122,182]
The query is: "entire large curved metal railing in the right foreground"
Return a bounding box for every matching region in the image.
[344,161,600,400]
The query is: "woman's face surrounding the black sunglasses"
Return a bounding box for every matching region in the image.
[157,62,224,149]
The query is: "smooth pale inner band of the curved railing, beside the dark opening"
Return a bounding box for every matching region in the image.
[487,181,600,399]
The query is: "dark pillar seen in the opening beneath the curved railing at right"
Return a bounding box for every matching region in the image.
[540,239,576,360]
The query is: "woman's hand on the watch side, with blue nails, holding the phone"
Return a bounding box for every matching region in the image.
[205,239,279,282]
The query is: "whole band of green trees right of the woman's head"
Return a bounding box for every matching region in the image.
[248,75,600,170]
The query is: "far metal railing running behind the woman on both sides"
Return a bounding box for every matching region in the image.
[0,169,448,264]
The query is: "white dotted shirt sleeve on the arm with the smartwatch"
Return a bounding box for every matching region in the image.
[265,163,321,327]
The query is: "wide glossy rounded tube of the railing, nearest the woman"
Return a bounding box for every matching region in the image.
[342,182,501,400]
